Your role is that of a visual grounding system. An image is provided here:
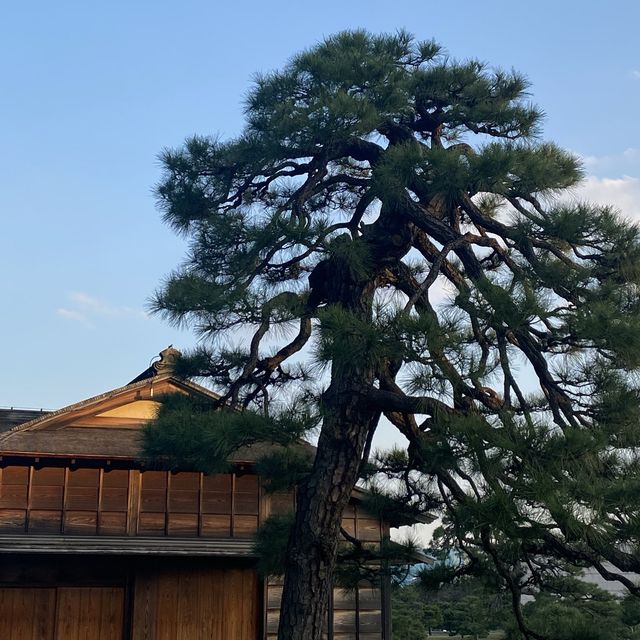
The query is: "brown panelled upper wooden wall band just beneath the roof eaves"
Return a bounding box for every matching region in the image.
[0,466,261,538]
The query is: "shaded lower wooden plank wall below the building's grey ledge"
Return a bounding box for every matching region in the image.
[0,556,261,640]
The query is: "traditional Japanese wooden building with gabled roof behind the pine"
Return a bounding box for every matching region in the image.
[0,349,404,640]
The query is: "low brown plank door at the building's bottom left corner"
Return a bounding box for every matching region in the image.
[0,587,124,640]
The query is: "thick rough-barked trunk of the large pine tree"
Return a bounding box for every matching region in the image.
[278,259,377,640]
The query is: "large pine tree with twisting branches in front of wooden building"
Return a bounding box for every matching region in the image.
[146,31,640,640]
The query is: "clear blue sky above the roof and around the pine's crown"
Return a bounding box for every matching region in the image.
[0,0,640,408]
